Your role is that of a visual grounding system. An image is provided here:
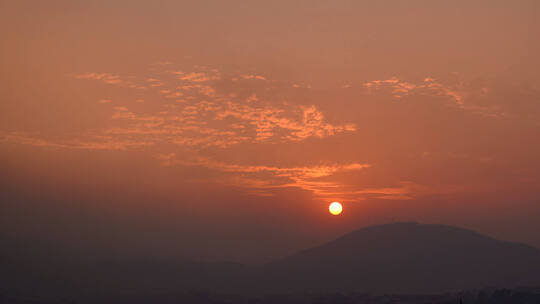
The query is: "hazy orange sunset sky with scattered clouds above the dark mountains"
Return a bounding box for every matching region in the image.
[0,0,540,263]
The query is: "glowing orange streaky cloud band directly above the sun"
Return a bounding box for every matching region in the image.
[153,153,452,202]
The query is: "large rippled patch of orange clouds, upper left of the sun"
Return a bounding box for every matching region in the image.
[64,67,356,148]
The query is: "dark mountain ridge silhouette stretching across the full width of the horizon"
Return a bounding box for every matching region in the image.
[0,223,540,301]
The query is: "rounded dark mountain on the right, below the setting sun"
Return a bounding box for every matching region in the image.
[265,223,540,293]
